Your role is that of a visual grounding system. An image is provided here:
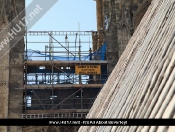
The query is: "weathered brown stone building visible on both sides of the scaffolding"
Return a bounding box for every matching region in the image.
[0,0,155,132]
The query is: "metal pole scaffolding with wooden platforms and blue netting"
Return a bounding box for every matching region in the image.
[19,31,108,118]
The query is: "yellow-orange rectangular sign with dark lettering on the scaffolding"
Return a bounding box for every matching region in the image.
[75,65,101,75]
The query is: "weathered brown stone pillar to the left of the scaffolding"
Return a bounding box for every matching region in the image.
[0,0,25,132]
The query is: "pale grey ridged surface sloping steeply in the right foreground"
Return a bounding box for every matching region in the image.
[78,0,175,132]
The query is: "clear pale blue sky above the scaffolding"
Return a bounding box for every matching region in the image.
[26,0,97,53]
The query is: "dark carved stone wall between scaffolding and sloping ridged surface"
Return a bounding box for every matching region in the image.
[95,0,151,73]
